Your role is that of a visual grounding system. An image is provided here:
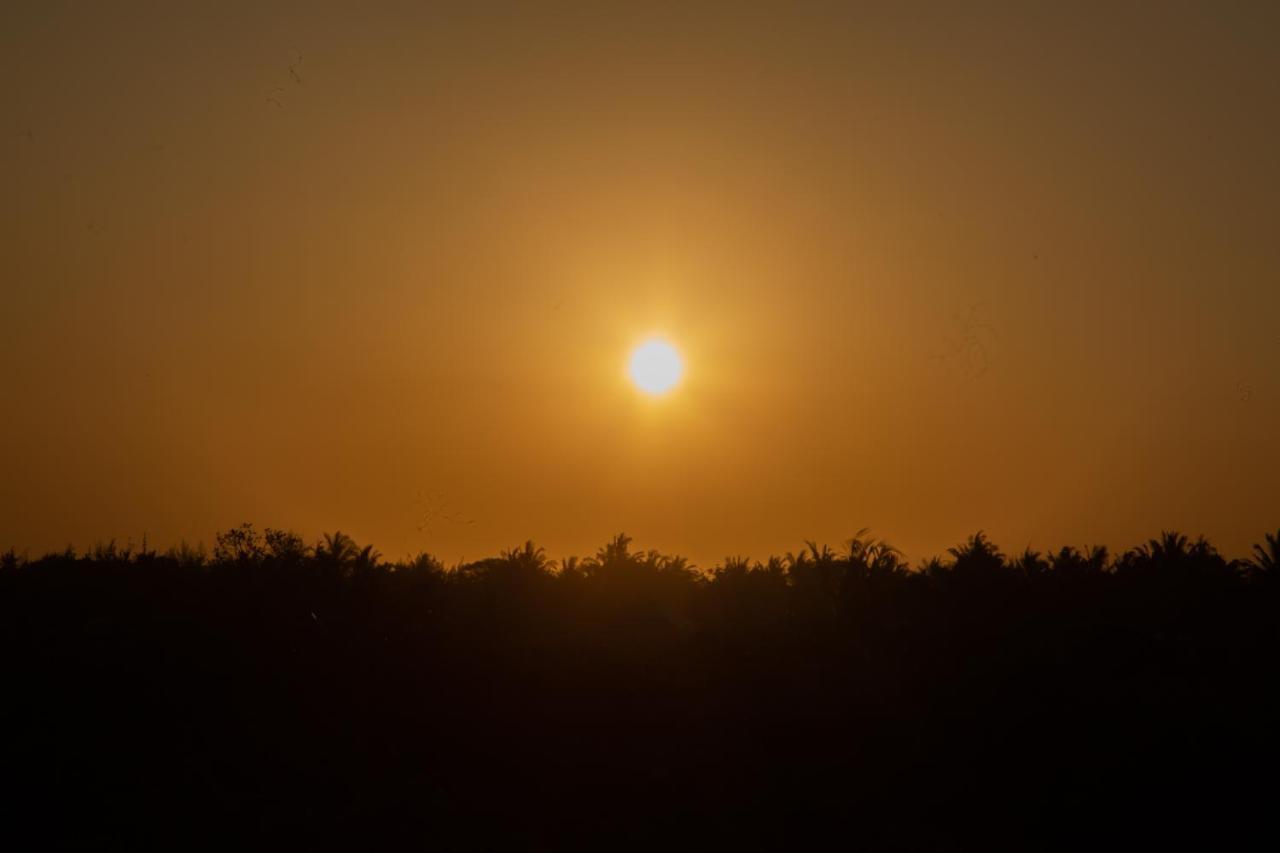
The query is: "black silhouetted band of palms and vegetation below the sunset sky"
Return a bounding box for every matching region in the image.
[0,525,1280,849]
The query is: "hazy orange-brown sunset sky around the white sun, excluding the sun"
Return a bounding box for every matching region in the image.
[0,0,1280,566]
